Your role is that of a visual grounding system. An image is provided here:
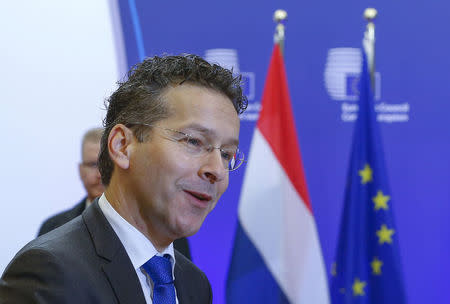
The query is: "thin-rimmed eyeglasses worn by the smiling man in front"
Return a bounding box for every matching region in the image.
[128,123,244,171]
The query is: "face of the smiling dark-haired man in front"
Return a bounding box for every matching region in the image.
[129,84,239,239]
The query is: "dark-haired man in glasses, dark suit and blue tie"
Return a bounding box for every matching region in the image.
[0,55,246,304]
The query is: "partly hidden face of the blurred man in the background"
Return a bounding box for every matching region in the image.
[79,141,104,201]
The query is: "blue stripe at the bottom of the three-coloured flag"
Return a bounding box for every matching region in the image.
[227,222,289,304]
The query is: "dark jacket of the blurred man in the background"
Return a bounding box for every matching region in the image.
[38,197,192,260]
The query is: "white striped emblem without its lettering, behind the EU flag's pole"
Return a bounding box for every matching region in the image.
[324,48,380,101]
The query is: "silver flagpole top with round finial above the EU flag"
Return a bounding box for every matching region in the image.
[363,7,378,89]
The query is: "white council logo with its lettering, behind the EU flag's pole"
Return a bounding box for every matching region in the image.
[324,48,409,123]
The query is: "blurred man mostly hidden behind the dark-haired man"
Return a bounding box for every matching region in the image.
[38,128,191,259]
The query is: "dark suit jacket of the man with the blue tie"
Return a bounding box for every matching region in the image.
[0,200,212,304]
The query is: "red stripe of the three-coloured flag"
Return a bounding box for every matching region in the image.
[257,45,312,213]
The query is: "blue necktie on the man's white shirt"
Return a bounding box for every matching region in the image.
[142,254,176,304]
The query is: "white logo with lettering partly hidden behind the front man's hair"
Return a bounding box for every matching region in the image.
[204,49,261,121]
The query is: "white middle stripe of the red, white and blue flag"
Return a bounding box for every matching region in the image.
[238,128,329,303]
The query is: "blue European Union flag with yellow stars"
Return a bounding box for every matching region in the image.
[331,51,406,304]
